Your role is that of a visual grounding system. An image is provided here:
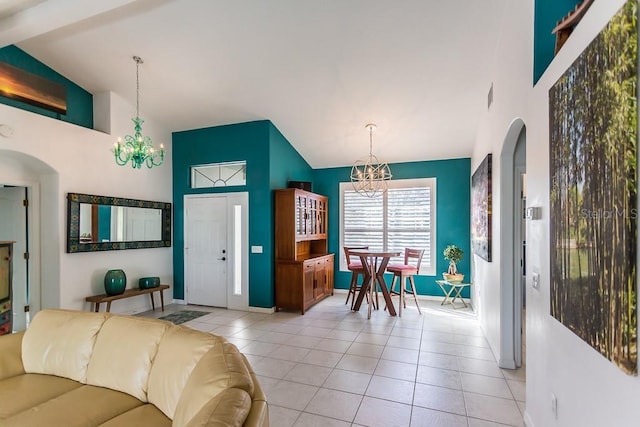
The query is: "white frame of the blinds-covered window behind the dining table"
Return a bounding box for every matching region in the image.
[339,178,437,276]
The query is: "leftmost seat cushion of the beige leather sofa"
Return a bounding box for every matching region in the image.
[0,374,82,425]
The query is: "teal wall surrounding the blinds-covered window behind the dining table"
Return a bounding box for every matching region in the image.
[313,158,471,297]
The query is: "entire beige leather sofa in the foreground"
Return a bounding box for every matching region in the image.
[0,310,269,427]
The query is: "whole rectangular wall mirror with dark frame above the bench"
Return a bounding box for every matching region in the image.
[67,193,171,253]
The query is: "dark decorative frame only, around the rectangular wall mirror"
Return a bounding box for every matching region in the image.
[67,193,171,253]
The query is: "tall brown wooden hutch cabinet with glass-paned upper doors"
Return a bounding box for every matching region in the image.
[274,188,333,314]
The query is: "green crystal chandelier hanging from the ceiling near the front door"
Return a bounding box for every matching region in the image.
[113,56,164,169]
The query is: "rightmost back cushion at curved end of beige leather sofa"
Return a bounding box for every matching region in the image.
[173,344,254,426]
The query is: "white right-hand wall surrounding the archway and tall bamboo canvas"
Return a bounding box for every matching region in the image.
[472,0,640,427]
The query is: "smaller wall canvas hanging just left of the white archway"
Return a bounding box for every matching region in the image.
[471,154,491,262]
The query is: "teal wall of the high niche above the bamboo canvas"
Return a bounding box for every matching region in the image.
[533,0,582,85]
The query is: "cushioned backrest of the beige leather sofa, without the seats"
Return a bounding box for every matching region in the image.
[22,310,254,425]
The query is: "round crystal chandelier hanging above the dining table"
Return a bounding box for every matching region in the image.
[351,123,391,197]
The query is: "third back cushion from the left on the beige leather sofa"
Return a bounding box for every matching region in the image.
[147,326,220,419]
